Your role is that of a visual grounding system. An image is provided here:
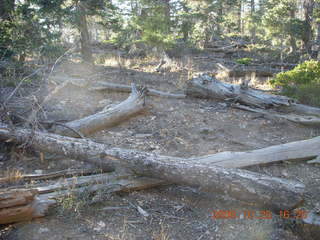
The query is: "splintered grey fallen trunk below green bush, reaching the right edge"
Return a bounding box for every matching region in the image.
[186,74,320,121]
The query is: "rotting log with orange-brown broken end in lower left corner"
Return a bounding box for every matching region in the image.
[0,173,165,224]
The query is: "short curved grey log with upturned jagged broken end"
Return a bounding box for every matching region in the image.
[54,85,147,137]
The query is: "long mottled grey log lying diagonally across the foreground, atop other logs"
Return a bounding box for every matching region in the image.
[0,124,304,210]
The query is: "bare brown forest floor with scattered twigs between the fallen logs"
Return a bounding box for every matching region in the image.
[0,47,320,240]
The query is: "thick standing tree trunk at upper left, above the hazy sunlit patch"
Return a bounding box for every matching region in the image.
[77,1,93,63]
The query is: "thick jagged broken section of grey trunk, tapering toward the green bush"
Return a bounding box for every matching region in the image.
[186,74,294,108]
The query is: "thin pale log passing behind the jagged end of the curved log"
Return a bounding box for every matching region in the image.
[89,82,186,99]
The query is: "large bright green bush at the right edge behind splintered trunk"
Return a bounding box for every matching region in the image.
[270,60,320,106]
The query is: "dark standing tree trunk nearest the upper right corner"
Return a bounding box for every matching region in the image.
[302,0,314,56]
